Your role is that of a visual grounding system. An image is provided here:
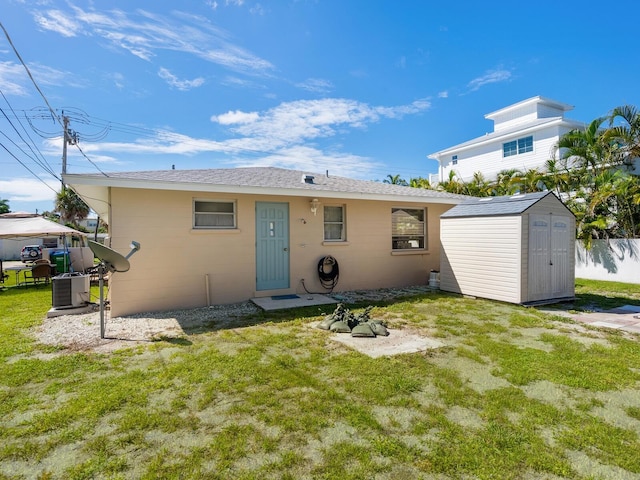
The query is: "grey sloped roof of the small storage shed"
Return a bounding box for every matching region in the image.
[440,191,560,218]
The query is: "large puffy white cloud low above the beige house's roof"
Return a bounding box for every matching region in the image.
[56,98,430,178]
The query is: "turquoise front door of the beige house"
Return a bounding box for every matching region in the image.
[256,202,289,290]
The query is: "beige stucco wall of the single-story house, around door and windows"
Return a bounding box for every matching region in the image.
[109,188,451,316]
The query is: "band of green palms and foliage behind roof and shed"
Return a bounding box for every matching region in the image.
[385,105,640,242]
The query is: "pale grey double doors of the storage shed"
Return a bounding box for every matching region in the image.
[528,214,572,301]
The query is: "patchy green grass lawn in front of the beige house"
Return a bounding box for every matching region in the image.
[0,280,640,479]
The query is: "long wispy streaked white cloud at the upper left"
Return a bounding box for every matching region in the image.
[33,2,274,75]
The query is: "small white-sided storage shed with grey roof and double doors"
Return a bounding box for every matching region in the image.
[440,192,576,304]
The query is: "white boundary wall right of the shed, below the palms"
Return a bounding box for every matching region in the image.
[576,238,640,284]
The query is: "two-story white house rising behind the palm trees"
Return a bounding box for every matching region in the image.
[428,96,585,184]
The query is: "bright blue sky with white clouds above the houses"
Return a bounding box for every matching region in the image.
[0,0,640,212]
